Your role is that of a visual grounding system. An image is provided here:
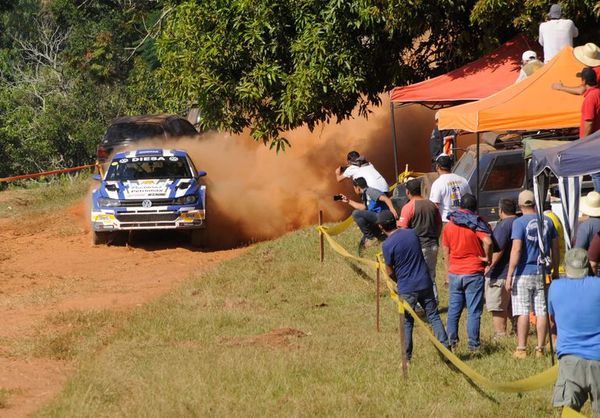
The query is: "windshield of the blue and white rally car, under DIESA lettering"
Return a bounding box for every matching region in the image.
[106,157,193,181]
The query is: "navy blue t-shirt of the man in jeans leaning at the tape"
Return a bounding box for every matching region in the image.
[382,229,433,294]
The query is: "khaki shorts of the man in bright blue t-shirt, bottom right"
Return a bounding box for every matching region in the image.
[552,355,600,415]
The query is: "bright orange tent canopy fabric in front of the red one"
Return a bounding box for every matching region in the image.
[437,47,584,132]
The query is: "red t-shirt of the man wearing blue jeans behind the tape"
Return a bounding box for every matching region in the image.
[442,222,489,274]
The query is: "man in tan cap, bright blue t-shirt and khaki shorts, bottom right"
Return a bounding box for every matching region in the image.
[548,248,600,415]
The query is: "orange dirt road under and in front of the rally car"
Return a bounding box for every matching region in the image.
[0,203,245,418]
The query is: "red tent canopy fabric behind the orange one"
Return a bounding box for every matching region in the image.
[390,36,539,104]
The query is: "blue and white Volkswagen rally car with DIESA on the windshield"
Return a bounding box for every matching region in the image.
[91,149,206,245]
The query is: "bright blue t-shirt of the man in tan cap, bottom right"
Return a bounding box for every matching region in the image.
[548,276,600,360]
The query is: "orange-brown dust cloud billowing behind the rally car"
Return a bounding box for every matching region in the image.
[131,97,433,248]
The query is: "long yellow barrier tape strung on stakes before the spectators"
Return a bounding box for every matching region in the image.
[317,219,564,392]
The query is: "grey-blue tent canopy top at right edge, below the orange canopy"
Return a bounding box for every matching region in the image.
[531,131,600,177]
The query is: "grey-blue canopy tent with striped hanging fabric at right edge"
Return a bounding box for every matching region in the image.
[530,131,600,253]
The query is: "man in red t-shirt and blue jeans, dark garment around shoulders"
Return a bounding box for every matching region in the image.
[442,193,492,351]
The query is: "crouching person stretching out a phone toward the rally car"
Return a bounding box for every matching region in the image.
[341,177,398,253]
